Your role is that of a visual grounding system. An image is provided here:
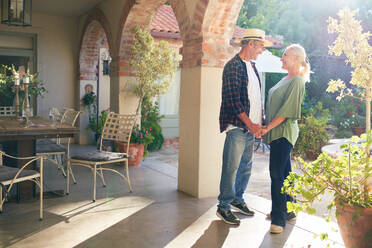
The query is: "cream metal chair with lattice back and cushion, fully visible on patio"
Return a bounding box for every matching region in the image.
[66,112,138,202]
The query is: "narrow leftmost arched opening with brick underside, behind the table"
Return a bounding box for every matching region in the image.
[79,19,111,144]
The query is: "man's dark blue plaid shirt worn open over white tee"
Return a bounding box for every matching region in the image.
[220,54,264,133]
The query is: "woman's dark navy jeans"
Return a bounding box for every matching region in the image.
[270,138,293,227]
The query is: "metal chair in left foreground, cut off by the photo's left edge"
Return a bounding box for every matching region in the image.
[0,150,44,220]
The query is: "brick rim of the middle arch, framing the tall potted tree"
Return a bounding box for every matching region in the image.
[116,0,190,76]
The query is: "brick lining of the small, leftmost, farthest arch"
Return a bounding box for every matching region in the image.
[79,9,113,80]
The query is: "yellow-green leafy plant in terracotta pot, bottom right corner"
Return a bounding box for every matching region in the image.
[282,131,372,247]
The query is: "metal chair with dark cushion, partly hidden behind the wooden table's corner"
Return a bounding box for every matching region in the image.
[36,109,81,183]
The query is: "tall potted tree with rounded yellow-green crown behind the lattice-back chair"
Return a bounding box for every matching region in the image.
[117,26,180,163]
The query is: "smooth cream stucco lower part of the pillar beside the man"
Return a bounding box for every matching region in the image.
[178,67,225,197]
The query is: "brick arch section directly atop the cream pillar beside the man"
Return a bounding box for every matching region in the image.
[182,0,244,67]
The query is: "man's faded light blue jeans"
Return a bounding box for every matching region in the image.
[218,128,254,210]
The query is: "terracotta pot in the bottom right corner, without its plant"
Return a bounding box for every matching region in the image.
[336,202,372,248]
